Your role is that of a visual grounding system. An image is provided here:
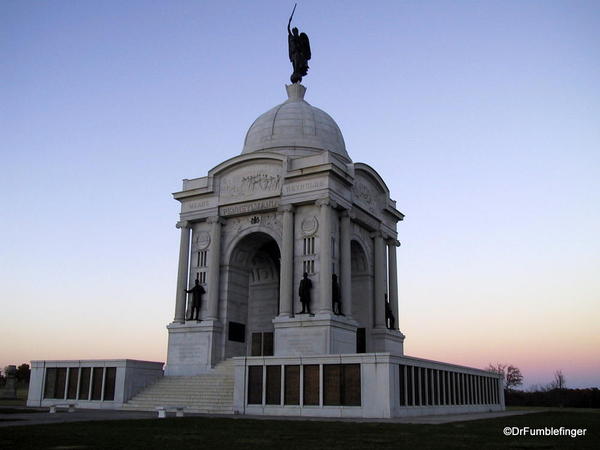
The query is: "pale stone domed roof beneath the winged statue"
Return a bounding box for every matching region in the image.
[242,83,350,161]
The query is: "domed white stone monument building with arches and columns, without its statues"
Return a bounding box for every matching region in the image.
[166,84,404,375]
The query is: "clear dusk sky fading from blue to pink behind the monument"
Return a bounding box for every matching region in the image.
[0,0,600,388]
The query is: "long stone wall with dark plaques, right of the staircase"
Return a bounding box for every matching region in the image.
[234,353,504,418]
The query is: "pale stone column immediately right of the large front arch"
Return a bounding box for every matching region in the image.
[279,205,294,317]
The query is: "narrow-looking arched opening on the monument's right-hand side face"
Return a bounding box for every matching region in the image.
[350,240,374,353]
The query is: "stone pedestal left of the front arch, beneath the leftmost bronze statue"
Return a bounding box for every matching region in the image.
[165,320,223,376]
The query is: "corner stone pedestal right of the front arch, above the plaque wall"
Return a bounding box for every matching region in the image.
[273,314,357,356]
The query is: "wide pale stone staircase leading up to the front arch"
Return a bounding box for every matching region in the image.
[123,360,234,414]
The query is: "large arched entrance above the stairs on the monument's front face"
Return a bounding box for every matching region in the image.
[224,232,280,358]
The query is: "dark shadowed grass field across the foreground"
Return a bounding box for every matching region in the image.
[0,410,600,450]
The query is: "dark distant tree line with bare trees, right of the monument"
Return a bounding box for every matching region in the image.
[486,363,600,408]
